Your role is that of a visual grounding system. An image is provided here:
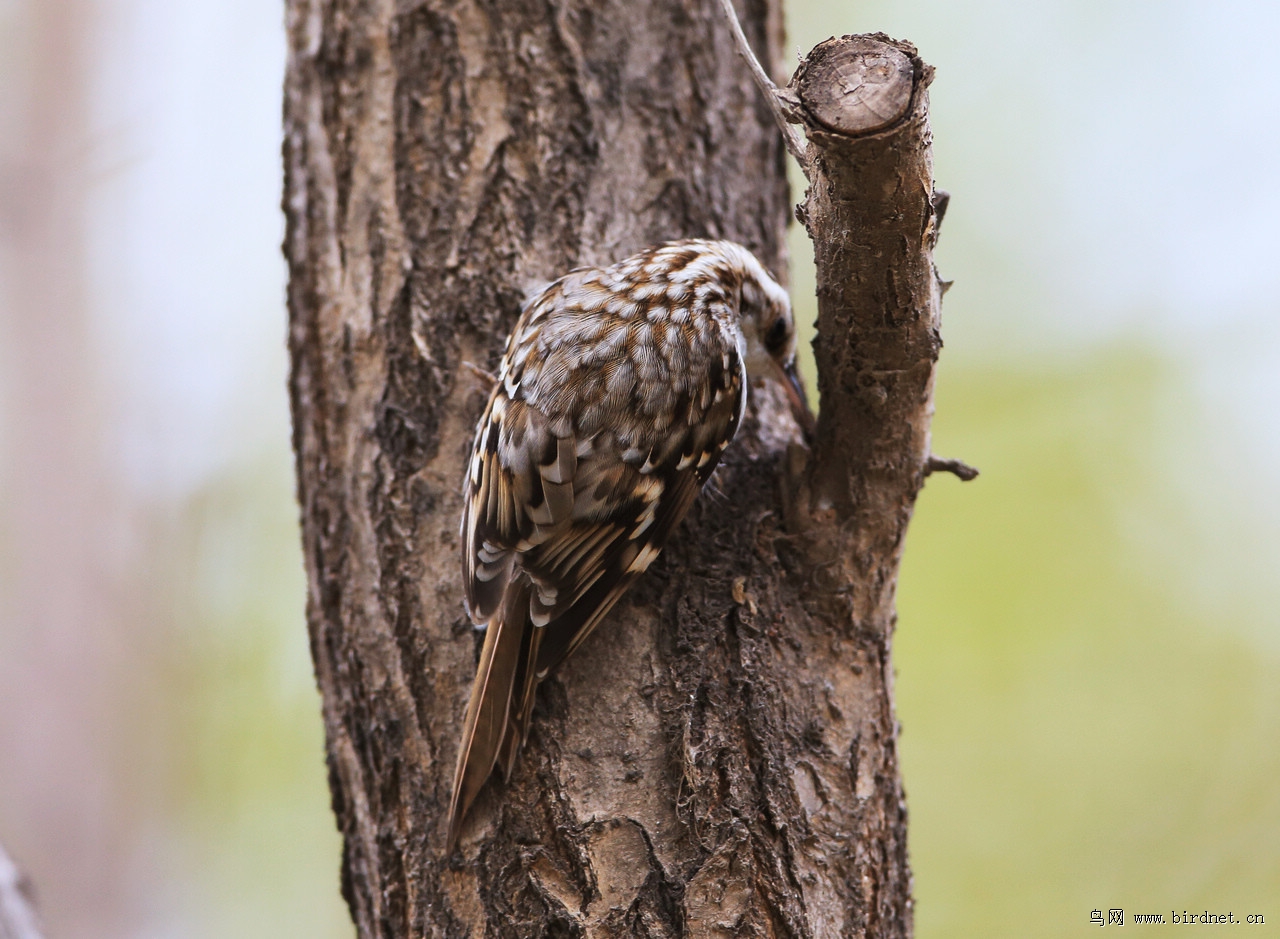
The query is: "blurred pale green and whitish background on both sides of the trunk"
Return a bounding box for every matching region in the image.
[0,0,1280,939]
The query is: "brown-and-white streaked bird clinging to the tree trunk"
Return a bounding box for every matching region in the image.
[447,239,812,849]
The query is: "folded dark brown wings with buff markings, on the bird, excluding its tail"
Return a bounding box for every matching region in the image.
[462,337,745,654]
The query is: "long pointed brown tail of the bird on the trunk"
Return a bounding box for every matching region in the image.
[448,582,536,851]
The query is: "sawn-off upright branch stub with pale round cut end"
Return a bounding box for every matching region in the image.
[791,33,941,532]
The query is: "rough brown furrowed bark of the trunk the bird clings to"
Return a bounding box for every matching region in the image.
[284,0,937,939]
